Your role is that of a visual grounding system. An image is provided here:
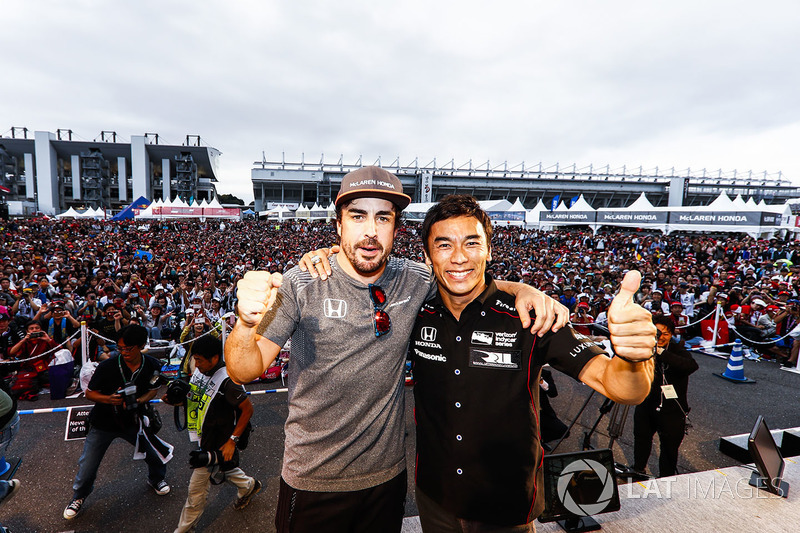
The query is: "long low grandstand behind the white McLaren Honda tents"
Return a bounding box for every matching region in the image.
[251,154,800,211]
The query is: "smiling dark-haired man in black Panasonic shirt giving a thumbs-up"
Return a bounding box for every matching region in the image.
[409,195,656,533]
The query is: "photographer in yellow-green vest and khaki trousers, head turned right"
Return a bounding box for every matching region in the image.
[162,335,261,533]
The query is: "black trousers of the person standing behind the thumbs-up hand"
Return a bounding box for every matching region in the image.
[633,400,686,477]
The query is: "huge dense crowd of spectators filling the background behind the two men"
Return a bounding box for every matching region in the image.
[0,214,800,396]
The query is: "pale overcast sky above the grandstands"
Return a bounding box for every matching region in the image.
[0,0,800,202]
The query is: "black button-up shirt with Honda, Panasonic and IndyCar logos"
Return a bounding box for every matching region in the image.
[409,275,604,525]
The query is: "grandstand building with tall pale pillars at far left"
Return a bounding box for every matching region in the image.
[0,127,221,215]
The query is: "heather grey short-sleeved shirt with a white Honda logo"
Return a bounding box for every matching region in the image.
[259,256,436,492]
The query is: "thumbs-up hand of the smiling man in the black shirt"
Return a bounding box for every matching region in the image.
[608,270,657,361]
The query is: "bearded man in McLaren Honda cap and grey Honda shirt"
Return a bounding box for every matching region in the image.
[225,167,566,533]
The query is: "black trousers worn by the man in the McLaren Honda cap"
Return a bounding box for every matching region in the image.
[275,470,408,533]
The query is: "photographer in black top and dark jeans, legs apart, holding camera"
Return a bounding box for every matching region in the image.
[64,325,172,520]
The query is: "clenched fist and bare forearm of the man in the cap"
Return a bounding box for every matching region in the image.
[225,271,283,384]
